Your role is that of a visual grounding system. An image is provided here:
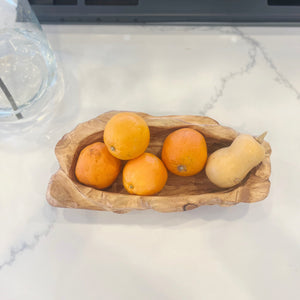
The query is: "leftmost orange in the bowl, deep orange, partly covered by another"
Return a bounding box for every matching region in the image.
[75,142,121,189]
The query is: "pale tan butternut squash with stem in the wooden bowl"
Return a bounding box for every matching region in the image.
[205,133,266,188]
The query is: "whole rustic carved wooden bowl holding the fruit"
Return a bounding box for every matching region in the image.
[47,111,271,213]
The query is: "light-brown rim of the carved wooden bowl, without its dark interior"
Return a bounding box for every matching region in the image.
[46,111,271,213]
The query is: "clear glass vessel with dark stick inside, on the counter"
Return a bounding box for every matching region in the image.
[0,0,63,132]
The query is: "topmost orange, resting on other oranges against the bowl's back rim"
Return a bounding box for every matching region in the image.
[103,112,150,160]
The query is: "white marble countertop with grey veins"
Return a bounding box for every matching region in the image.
[0,26,300,300]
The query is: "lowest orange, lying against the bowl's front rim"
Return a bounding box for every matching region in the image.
[123,153,168,195]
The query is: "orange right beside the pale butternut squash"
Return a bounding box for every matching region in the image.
[161,128,207,176]
